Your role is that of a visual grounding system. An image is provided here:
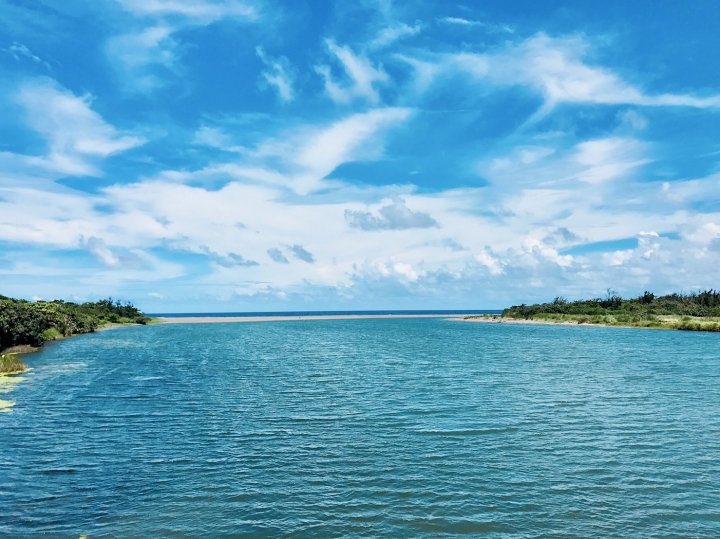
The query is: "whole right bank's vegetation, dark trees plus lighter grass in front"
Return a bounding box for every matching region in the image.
[502,290,720,331]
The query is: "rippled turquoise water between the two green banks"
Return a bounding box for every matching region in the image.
[0,319,720,538]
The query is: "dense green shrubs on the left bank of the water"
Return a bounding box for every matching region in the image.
[0,296,150,350]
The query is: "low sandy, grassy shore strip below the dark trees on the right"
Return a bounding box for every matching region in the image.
[462,314,720,332]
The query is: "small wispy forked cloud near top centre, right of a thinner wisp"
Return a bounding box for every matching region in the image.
[315,39,389,103]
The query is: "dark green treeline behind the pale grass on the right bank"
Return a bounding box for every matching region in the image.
[503,290,720,319]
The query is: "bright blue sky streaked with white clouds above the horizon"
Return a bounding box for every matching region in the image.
[0,0,720,312]
